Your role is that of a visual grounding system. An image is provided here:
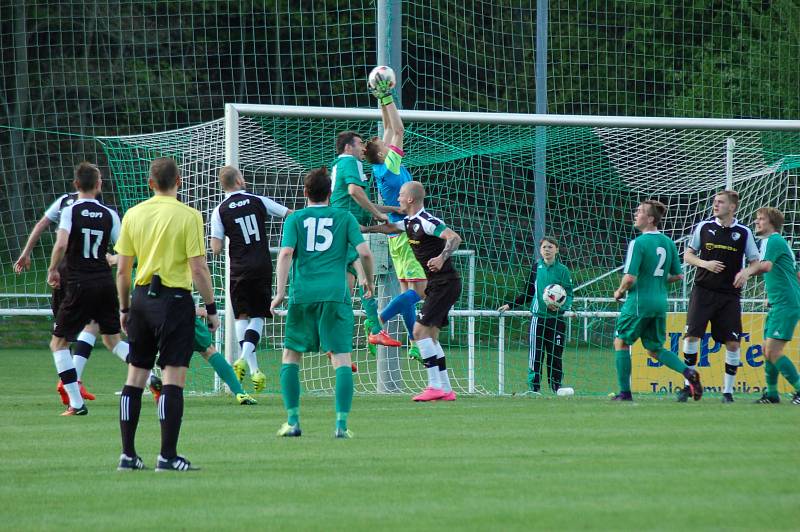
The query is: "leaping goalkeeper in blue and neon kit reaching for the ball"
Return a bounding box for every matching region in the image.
[365,76,428,360]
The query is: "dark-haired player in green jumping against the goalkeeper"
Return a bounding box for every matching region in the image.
[330,131,402,354]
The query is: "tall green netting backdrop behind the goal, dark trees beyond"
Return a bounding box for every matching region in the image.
[0,0,800,390]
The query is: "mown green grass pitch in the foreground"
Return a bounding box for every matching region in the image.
[0,349,800,531]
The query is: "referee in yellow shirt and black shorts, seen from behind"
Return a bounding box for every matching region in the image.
[115,158,219,471]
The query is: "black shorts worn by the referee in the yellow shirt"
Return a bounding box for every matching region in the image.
[128,286,194,369]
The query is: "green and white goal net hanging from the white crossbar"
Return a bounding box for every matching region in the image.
[89,106,800,394]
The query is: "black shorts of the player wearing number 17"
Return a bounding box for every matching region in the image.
[53,276,120,340]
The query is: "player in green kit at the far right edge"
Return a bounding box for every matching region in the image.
[734,207,800,405]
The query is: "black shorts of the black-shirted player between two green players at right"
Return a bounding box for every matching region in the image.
[686,286,742,343]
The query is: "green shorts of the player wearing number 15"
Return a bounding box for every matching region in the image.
[283,301,353,354]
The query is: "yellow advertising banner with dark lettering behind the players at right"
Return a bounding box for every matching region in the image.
[631,312,800,394]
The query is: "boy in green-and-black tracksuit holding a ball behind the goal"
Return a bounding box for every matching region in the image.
[497,236,573,393]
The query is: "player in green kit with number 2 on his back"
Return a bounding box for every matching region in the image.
[614,200,703,401]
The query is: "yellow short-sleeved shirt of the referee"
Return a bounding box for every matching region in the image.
[114,196,206,290]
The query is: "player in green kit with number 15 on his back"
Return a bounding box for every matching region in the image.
[270,168,375,438]
